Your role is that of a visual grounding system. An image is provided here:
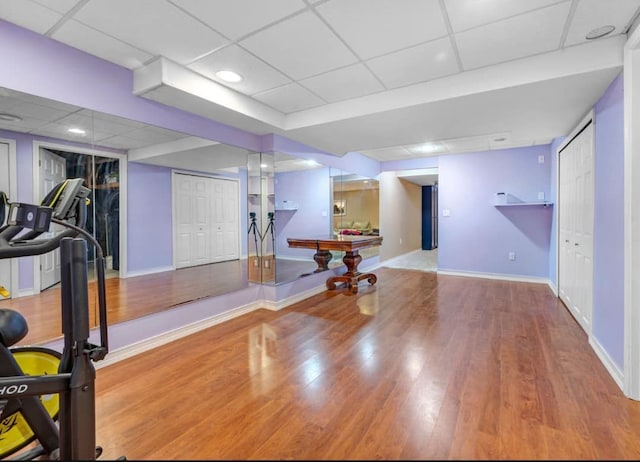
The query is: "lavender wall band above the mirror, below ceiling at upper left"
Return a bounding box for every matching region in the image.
[0,20,261,151]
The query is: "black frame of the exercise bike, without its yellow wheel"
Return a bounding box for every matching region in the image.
[0,179,108,460]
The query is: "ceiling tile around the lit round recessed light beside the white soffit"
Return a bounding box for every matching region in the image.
[187,45,291,95]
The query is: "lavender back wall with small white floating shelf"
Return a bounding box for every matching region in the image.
[438,145,552,279]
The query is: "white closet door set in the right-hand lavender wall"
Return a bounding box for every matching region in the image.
[558,120,594,333]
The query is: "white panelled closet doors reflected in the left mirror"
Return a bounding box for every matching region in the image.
[173,173,240,268]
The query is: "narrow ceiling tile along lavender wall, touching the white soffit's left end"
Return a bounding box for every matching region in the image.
[51,20,153,69]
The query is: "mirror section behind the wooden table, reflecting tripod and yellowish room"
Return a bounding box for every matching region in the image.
[247,157,380,284]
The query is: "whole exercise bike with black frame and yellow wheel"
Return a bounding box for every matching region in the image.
[0,178,112,460]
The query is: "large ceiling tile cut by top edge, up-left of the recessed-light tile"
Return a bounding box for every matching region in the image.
[74,0,227,64]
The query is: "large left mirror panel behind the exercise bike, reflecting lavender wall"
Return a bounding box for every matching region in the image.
[0,89,255,345]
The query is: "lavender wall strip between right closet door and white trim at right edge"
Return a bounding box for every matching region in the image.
[593,75,624,370]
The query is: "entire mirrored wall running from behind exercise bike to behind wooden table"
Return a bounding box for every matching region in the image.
[0,85,378,344]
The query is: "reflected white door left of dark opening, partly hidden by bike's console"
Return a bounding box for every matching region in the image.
[39,148,67,290]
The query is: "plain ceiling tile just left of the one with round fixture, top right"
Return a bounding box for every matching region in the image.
[455,2,570,70]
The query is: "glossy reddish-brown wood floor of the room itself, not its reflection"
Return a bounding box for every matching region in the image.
[97,268,640,460]
